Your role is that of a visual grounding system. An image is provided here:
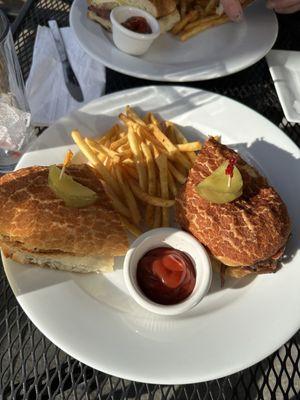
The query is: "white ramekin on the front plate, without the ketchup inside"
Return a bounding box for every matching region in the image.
[123,228,212,315]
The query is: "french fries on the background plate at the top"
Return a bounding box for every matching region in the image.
[171,0,252,41]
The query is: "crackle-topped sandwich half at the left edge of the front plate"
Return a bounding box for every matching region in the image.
[0,164,128,272]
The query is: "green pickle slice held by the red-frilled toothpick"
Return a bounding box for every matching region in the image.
[196,161,243,204]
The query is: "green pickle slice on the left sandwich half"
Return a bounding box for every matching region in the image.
[48,165,98,208]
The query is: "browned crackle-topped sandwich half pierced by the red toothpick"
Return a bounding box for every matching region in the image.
[176,138,291,278]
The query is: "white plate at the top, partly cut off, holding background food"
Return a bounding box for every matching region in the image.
[70,0,278,82]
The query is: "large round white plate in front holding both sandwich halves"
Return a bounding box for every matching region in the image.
[3,86,300,384]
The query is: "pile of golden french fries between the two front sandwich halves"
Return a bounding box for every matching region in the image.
[72,106,201,236]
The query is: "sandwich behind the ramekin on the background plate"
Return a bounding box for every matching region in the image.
[87,0,180,33]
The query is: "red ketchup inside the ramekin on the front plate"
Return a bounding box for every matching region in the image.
[137,247,196,305]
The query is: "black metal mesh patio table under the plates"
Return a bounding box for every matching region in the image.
[0,0,300,400]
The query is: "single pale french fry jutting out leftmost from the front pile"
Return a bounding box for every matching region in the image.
[71,130,121,194]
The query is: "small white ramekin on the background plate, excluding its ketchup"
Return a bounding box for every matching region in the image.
[110,6,160,56]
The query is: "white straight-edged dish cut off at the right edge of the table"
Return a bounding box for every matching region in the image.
[267,50,300,122]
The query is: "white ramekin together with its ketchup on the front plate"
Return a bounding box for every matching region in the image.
[124,228,212,315]
